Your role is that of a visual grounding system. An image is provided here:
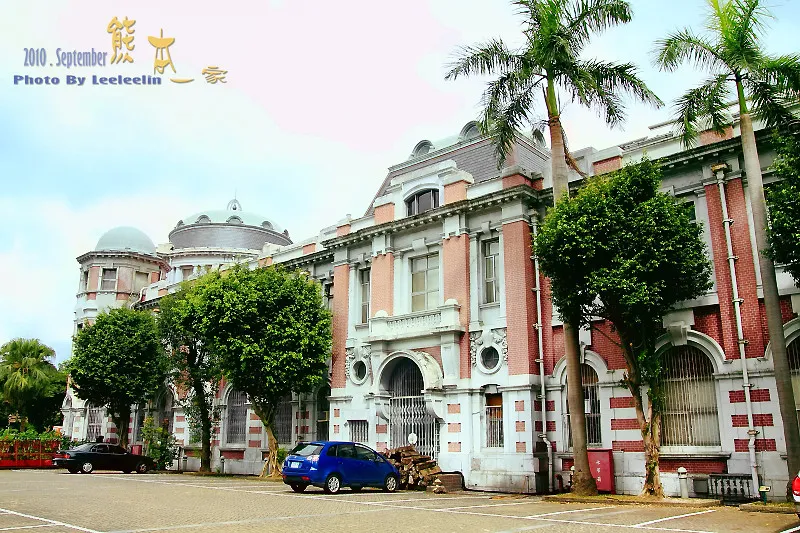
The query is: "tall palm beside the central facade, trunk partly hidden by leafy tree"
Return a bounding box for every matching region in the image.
[446,0,661,494]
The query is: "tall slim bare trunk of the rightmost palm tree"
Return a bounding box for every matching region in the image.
[740,109,800,490]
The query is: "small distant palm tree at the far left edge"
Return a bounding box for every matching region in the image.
[0,339,58,431]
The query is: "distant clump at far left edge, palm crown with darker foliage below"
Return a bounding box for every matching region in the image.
[0,339,59,431]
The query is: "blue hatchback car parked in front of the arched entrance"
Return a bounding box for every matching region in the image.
[283,441,400,494]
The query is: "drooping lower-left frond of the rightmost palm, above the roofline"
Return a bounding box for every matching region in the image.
[675,74,731,148]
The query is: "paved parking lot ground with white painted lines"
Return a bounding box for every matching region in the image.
[0,470,800,533]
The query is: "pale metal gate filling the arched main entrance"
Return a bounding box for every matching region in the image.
[389,359,439,459]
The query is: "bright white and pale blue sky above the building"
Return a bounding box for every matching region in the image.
[0,0,800,361]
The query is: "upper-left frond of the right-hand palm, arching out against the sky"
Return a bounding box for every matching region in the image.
[653,28,730,72]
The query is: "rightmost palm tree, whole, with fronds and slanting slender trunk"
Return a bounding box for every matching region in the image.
[655,0,800,486]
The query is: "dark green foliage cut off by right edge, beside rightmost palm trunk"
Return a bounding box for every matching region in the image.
[767,132,800,285]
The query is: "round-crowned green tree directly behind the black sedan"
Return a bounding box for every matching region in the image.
[67,308,167,447]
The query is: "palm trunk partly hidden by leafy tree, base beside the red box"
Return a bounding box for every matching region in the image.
[539,82,597,495]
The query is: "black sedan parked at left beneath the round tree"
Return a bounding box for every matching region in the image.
[53,443,155,474]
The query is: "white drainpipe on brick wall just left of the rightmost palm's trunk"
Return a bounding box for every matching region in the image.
[711,163,759,493]
